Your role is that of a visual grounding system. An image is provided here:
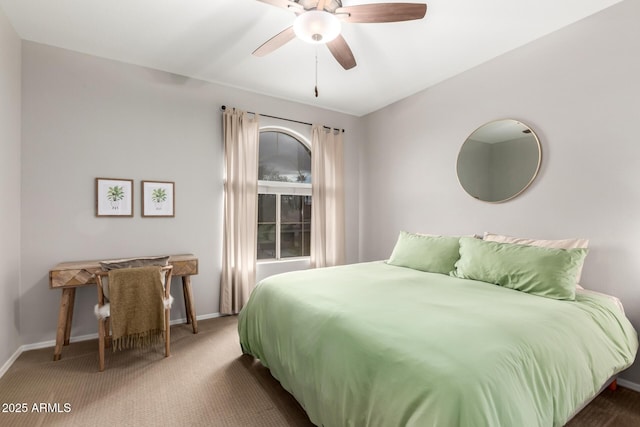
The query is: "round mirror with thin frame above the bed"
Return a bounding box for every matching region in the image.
[457,119,542,203]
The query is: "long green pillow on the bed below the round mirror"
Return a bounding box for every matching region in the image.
[451,237,588,300]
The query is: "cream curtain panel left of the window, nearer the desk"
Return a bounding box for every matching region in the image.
[220,109,260,314]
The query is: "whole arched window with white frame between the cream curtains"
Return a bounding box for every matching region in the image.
[257,128,311,260]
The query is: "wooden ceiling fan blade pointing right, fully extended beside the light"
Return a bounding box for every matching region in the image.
[335,3,427,23]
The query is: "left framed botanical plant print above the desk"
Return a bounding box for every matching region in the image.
[96,178,133,217]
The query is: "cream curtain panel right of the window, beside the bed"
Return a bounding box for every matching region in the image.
[311,125,345,267]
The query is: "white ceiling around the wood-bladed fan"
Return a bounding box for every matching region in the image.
[0,0,621,116]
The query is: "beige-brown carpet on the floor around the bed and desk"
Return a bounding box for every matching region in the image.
[0,317,640,427]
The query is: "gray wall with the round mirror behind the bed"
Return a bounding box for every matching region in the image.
[360,1,640,383]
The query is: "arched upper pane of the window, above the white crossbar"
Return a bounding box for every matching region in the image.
[258,131,311,183]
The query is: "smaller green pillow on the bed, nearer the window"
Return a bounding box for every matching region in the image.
[387,231,460,274]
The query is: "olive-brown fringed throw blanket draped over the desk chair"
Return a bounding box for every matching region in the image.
[109,266,165,351]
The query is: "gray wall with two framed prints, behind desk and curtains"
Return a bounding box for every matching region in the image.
[20,42,362,343]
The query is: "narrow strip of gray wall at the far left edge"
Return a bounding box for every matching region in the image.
[0,3,21,369]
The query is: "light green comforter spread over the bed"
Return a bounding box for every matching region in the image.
[238,262,638,427]
